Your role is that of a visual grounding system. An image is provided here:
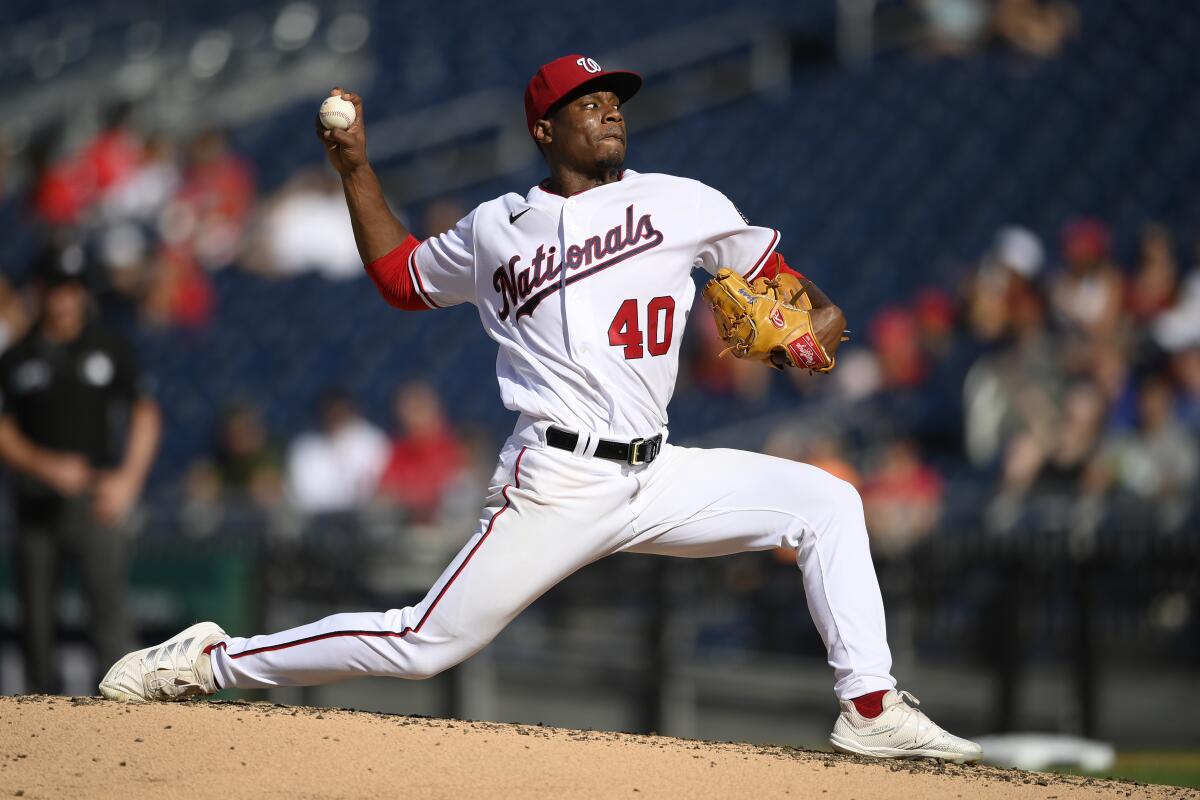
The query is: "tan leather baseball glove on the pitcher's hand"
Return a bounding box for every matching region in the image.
[704,267,834,372]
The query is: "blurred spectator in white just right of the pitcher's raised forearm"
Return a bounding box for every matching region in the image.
[251,167,362,278]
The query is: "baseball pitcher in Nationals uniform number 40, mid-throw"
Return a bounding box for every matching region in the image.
[100,55,982,763]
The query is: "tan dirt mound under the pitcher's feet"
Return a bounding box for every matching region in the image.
[0,696,1200,800]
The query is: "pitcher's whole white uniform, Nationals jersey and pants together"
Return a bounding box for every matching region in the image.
[210,170,895,714]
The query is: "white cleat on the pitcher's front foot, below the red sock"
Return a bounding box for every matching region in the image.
[829,690,983,764]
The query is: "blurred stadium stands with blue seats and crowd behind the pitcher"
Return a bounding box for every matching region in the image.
[0,0,1200,786]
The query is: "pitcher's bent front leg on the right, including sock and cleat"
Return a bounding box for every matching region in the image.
[628,447,983,762]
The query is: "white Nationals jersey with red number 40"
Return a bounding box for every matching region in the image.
[409,170,779,440]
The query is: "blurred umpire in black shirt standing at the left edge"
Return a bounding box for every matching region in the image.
[0,247,161,693]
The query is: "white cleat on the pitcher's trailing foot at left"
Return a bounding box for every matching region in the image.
[100,622,229,702]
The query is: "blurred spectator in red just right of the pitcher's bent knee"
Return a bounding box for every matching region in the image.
[863,439,942,554]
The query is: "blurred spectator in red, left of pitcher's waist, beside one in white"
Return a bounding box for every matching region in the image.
[379,383,469,523]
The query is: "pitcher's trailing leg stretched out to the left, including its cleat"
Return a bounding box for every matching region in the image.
[101,450,629,699]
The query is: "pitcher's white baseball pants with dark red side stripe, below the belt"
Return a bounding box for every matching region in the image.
[211,435,895,699]
